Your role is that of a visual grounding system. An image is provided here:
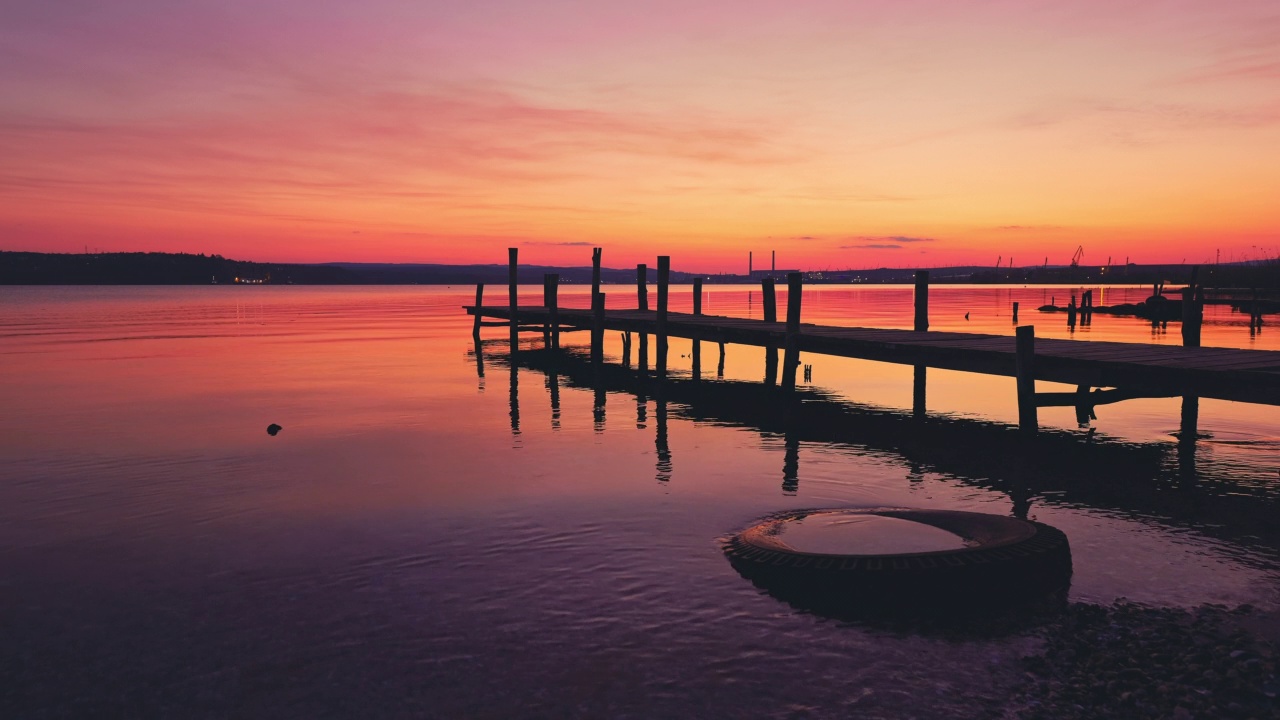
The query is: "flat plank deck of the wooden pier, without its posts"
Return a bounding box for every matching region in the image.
[466,299,1280,406]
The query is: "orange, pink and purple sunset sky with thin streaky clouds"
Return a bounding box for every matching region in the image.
[0,0,1280,272]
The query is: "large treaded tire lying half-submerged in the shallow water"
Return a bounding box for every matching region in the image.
[724,509,1071,612]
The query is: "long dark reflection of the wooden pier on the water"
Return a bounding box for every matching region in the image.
[478,350,1280,548]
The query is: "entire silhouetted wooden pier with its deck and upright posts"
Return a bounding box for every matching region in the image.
[466,251,1280,432]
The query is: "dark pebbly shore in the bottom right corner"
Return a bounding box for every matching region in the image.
[998,601,1280,720]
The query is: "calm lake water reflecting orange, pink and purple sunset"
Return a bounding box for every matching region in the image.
[0,286,1280,717]
